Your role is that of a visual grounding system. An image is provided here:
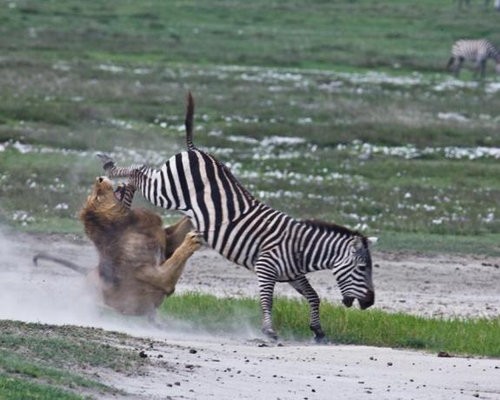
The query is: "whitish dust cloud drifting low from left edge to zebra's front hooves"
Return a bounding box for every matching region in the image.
[0,227,261,339]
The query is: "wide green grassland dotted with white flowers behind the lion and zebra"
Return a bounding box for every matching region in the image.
[0,0,500,250]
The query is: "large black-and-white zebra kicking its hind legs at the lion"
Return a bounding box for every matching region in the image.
[99,93,375,341]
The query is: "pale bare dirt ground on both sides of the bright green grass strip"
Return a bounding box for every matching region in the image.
[0,231,500,400]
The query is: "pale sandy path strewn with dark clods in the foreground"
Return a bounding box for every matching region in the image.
[98,332,500,400]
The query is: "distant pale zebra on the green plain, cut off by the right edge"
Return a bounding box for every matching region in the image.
[447,39,500,78]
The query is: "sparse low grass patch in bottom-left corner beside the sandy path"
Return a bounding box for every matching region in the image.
[0,320,151,400]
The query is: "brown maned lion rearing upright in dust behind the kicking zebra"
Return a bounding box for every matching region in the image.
[33,177,201,320]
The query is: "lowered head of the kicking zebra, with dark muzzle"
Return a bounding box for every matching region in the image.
[337,236,375,310]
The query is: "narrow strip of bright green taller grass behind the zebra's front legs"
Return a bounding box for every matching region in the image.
[161,293,500,357]
